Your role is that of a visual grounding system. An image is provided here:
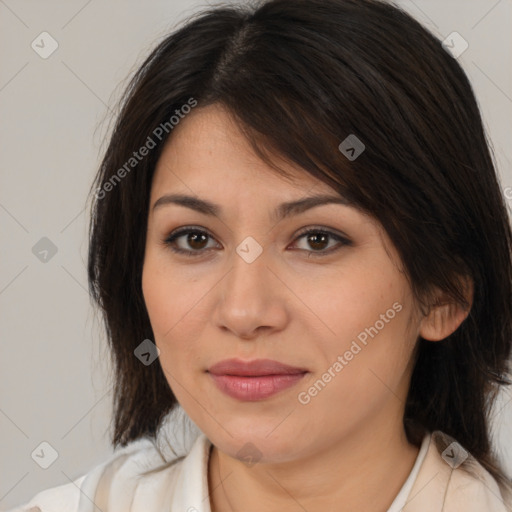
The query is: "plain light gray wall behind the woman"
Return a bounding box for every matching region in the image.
[0,0,512,510]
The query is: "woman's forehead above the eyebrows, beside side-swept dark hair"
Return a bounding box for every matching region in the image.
[152,105,336,198]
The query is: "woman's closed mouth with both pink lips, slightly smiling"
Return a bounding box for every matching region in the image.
[207,359,308,401]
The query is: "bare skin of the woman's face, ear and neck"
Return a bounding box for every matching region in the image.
[142,105,467,512]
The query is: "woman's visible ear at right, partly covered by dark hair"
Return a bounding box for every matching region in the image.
[419,277,473,341]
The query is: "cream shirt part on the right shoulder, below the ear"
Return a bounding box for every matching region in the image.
[404,431,512,512]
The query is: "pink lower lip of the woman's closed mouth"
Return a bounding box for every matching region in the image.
[210,373,306,401]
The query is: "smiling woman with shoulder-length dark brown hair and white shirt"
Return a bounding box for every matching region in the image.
[8,0,512,512]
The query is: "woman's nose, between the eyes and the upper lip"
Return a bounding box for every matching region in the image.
[214,239,289,340]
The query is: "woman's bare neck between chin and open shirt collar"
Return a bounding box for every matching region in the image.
[208,425,419,512]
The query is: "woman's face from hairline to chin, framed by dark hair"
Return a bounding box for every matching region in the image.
[142,106,419,462]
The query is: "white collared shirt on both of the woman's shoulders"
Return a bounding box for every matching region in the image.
[9,422,509,512]
